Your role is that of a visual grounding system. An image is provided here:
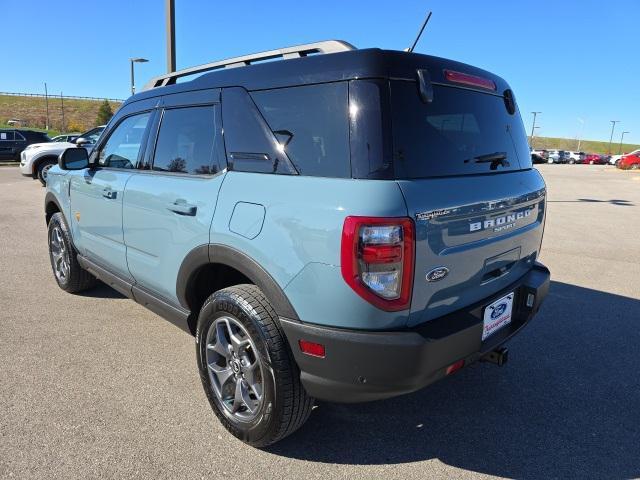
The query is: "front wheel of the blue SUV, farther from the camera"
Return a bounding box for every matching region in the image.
[48,212,97,293]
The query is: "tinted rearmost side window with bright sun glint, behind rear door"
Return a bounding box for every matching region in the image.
[251,82,351,177]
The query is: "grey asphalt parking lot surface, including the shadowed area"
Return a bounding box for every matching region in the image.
[0,165,640,479]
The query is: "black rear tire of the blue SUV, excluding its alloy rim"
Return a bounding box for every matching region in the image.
[196,284,313,447]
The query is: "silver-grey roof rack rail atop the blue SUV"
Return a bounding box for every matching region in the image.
[141,40,356,91]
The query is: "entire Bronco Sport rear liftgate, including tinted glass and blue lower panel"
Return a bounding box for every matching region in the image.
[390,79,545,325]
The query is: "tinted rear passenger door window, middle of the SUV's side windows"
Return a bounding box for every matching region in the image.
[153,105,218,175]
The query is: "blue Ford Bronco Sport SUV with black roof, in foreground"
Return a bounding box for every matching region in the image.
[45,41,549,447]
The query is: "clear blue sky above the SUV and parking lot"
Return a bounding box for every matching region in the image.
[5,0,640,143]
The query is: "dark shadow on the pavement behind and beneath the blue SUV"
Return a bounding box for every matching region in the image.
[269,282,640,478]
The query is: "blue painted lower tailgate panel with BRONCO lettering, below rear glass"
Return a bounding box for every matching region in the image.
[398,174,545,325]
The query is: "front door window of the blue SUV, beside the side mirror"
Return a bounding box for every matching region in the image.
[98,112,151,168]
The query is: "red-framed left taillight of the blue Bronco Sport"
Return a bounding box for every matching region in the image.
[341,217,415,312]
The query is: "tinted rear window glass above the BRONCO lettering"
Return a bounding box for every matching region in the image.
[391,81,531,178]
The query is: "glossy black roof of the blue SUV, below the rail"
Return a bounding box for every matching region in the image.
[125,48,509,103]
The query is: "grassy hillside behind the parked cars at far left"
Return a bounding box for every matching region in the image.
[0,95,121,135]
